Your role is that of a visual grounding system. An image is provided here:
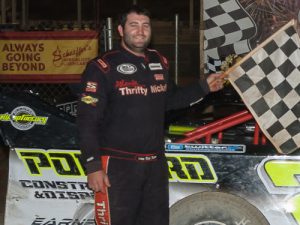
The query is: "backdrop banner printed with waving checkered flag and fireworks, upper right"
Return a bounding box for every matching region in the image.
[203,0,300,73]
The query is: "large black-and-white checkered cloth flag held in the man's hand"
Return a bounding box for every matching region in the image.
[226,21,300,154]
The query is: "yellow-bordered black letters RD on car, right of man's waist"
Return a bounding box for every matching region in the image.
[166,153,218,184]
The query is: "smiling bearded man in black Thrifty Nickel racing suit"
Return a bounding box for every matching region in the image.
[78,6,223,225]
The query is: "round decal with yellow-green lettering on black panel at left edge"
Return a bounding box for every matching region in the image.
[0,106,48,131]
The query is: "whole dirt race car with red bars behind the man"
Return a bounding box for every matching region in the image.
[0,90,300,225]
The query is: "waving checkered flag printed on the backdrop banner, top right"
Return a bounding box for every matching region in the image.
[203,0,256,59]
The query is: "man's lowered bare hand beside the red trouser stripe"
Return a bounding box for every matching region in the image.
[87,170,110,193]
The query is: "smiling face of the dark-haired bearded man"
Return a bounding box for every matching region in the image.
[118,13,151,54]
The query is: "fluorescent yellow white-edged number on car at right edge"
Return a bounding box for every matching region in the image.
[257,156,300,225]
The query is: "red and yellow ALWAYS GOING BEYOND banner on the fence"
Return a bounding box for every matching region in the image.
[0,31,98,82]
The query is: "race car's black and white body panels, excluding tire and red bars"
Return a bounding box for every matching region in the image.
[0,94,300,225]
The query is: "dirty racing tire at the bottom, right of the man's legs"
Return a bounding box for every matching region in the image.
[170,192,270,225]
